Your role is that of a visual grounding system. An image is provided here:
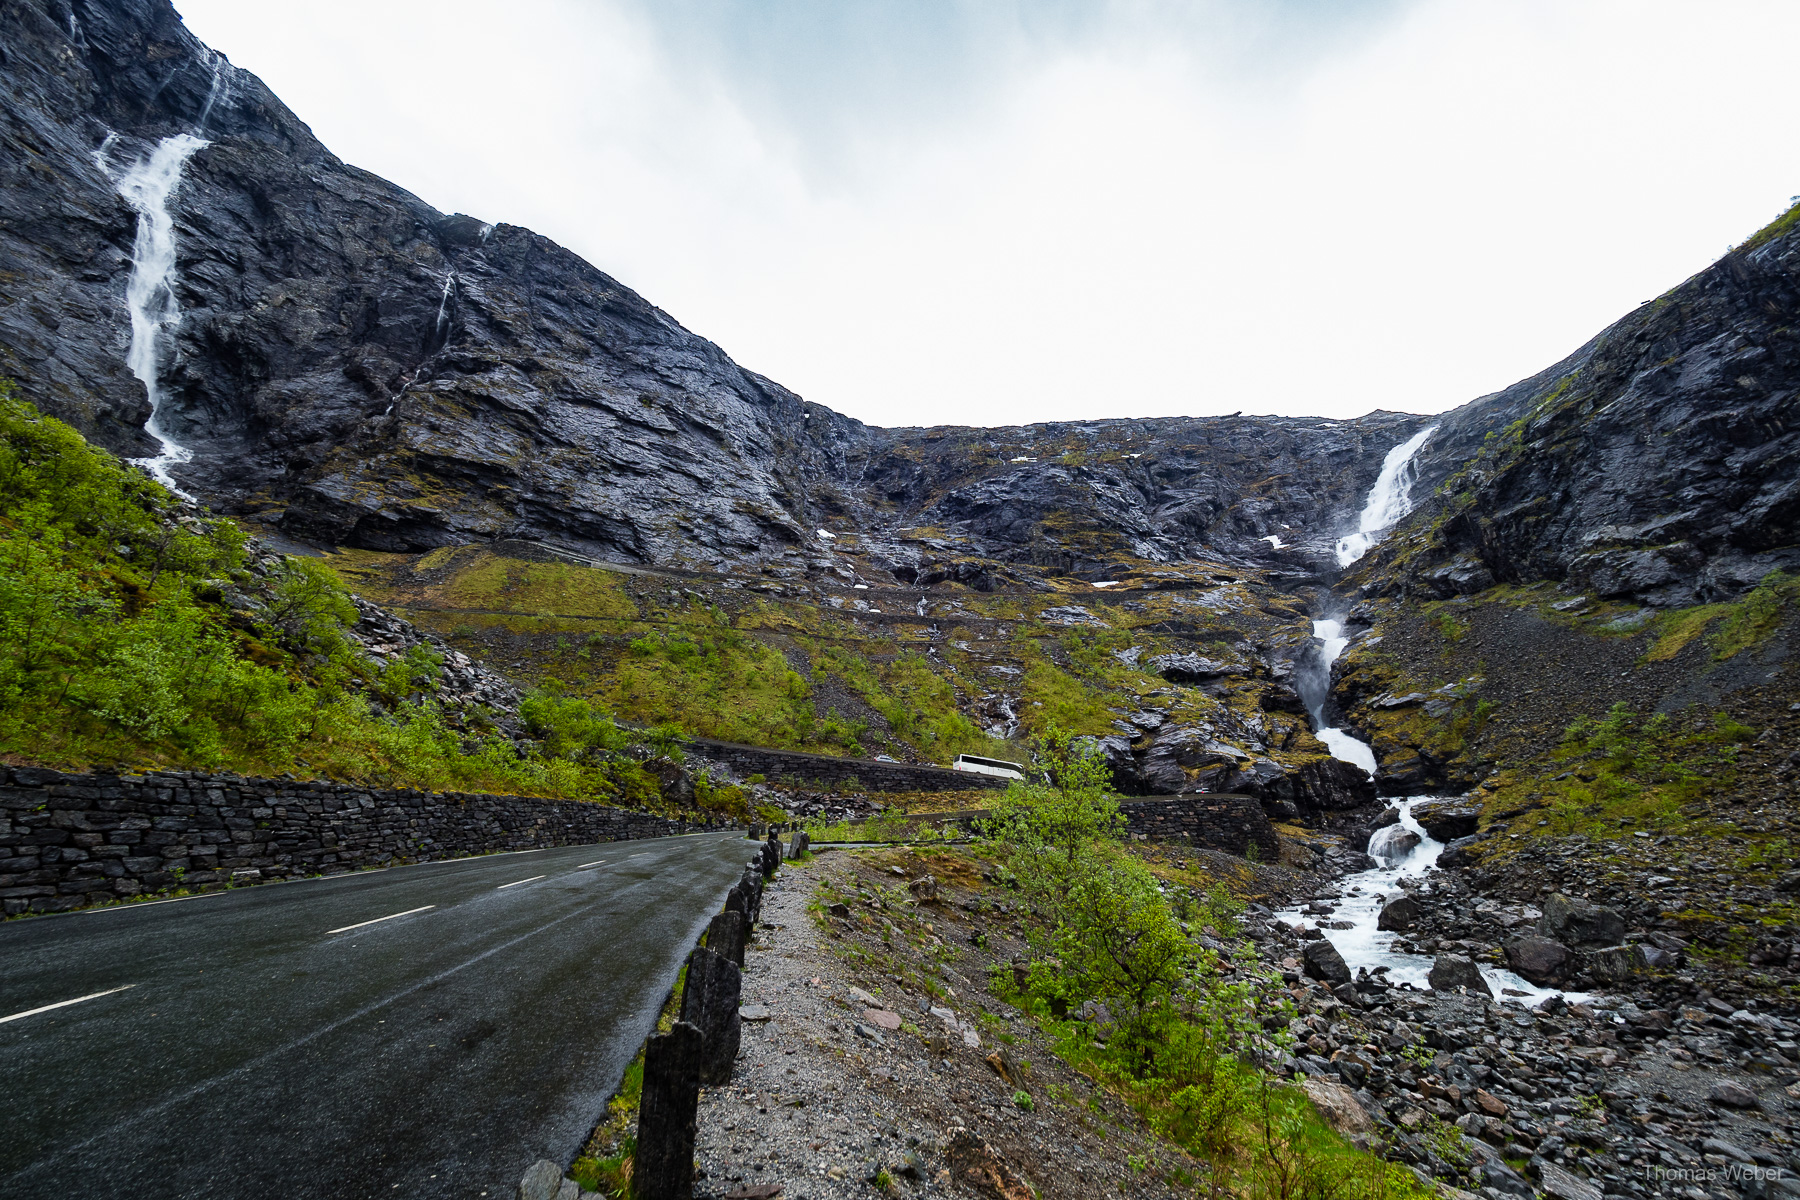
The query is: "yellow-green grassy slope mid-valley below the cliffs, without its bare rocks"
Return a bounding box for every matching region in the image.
[328,547,1353,780]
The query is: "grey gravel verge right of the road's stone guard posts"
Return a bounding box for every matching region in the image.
[695,853,1193,1200]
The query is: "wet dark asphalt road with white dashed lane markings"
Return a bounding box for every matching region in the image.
[0,833,756,1200]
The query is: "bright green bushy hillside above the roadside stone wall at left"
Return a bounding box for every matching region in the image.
[0,385,742,820]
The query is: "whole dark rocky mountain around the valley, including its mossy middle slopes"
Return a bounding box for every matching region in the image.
[0,0,1800,827]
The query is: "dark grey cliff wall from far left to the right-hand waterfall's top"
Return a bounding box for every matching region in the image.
[0,0,1447,574]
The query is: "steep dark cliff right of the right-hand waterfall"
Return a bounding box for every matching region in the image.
[1359,207,1800,606]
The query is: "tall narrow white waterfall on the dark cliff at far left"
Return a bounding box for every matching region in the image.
[108,133,209,500]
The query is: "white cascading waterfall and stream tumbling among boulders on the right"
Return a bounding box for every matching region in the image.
[1280,425,1562,1004]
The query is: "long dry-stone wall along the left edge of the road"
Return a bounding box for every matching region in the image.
[0,768,729,916]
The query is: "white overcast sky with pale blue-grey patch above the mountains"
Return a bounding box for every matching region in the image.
[178,0,1800,425]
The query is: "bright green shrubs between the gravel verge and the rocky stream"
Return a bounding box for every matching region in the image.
[815,729,1429,1200]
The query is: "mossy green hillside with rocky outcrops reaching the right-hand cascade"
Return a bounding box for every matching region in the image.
[326,534,1372,817]
